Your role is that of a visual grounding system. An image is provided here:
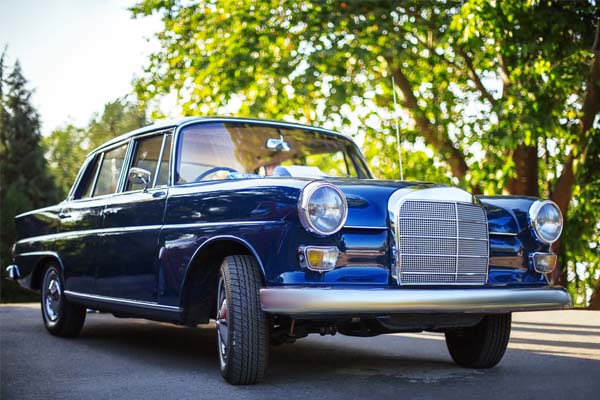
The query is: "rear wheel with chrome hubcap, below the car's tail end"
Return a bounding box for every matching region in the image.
[40,264,85,337]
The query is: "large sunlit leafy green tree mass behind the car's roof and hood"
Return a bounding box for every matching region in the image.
[132,0,600,304]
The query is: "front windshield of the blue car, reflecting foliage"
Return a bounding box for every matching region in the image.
[175,122,371,184]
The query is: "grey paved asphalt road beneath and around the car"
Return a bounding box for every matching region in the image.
[0,304,600,400]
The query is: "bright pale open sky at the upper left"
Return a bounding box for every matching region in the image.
[0,0,161,134]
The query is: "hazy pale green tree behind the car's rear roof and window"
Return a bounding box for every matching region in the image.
[43,97,148,198]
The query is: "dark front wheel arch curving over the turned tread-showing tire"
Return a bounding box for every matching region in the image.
[181,235,265,325]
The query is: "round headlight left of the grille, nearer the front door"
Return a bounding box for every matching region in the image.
[298,182,348,235]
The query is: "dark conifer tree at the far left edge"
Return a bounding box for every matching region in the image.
[0,52,57,301]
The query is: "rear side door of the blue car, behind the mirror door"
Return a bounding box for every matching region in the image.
[55,152,107,293]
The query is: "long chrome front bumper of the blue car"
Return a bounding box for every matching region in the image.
[260,287,571,315]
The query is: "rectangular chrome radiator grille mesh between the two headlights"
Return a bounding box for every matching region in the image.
[395,200,489,285]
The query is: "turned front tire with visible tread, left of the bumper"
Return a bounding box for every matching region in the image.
[217,255,269,385]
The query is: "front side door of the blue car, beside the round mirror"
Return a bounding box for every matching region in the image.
[96,132,171,302]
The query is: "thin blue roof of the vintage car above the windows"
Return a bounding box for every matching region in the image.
[88,116,353,156]
